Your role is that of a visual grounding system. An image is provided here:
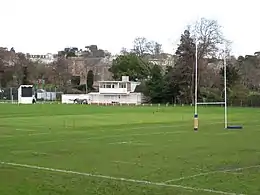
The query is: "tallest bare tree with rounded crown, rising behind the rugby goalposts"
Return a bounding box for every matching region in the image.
[185,18,231,100]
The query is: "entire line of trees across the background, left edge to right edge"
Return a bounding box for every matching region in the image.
[0,18,260,106]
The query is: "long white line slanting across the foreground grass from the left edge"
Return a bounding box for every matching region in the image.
[0,161,243,195]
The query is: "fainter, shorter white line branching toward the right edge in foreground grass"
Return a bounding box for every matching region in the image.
[164,165,260,183]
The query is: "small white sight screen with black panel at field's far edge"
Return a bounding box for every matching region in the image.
[18,85,34,104]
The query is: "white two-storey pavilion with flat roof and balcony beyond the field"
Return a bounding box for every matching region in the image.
[88,76,142,105]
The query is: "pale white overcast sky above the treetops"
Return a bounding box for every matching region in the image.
[0,0,260,56]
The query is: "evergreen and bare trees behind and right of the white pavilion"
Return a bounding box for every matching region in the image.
[110,18,260,106]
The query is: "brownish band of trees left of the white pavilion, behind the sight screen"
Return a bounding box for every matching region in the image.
[0,45,98,93]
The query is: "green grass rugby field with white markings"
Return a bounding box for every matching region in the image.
[0,104,260,195]
